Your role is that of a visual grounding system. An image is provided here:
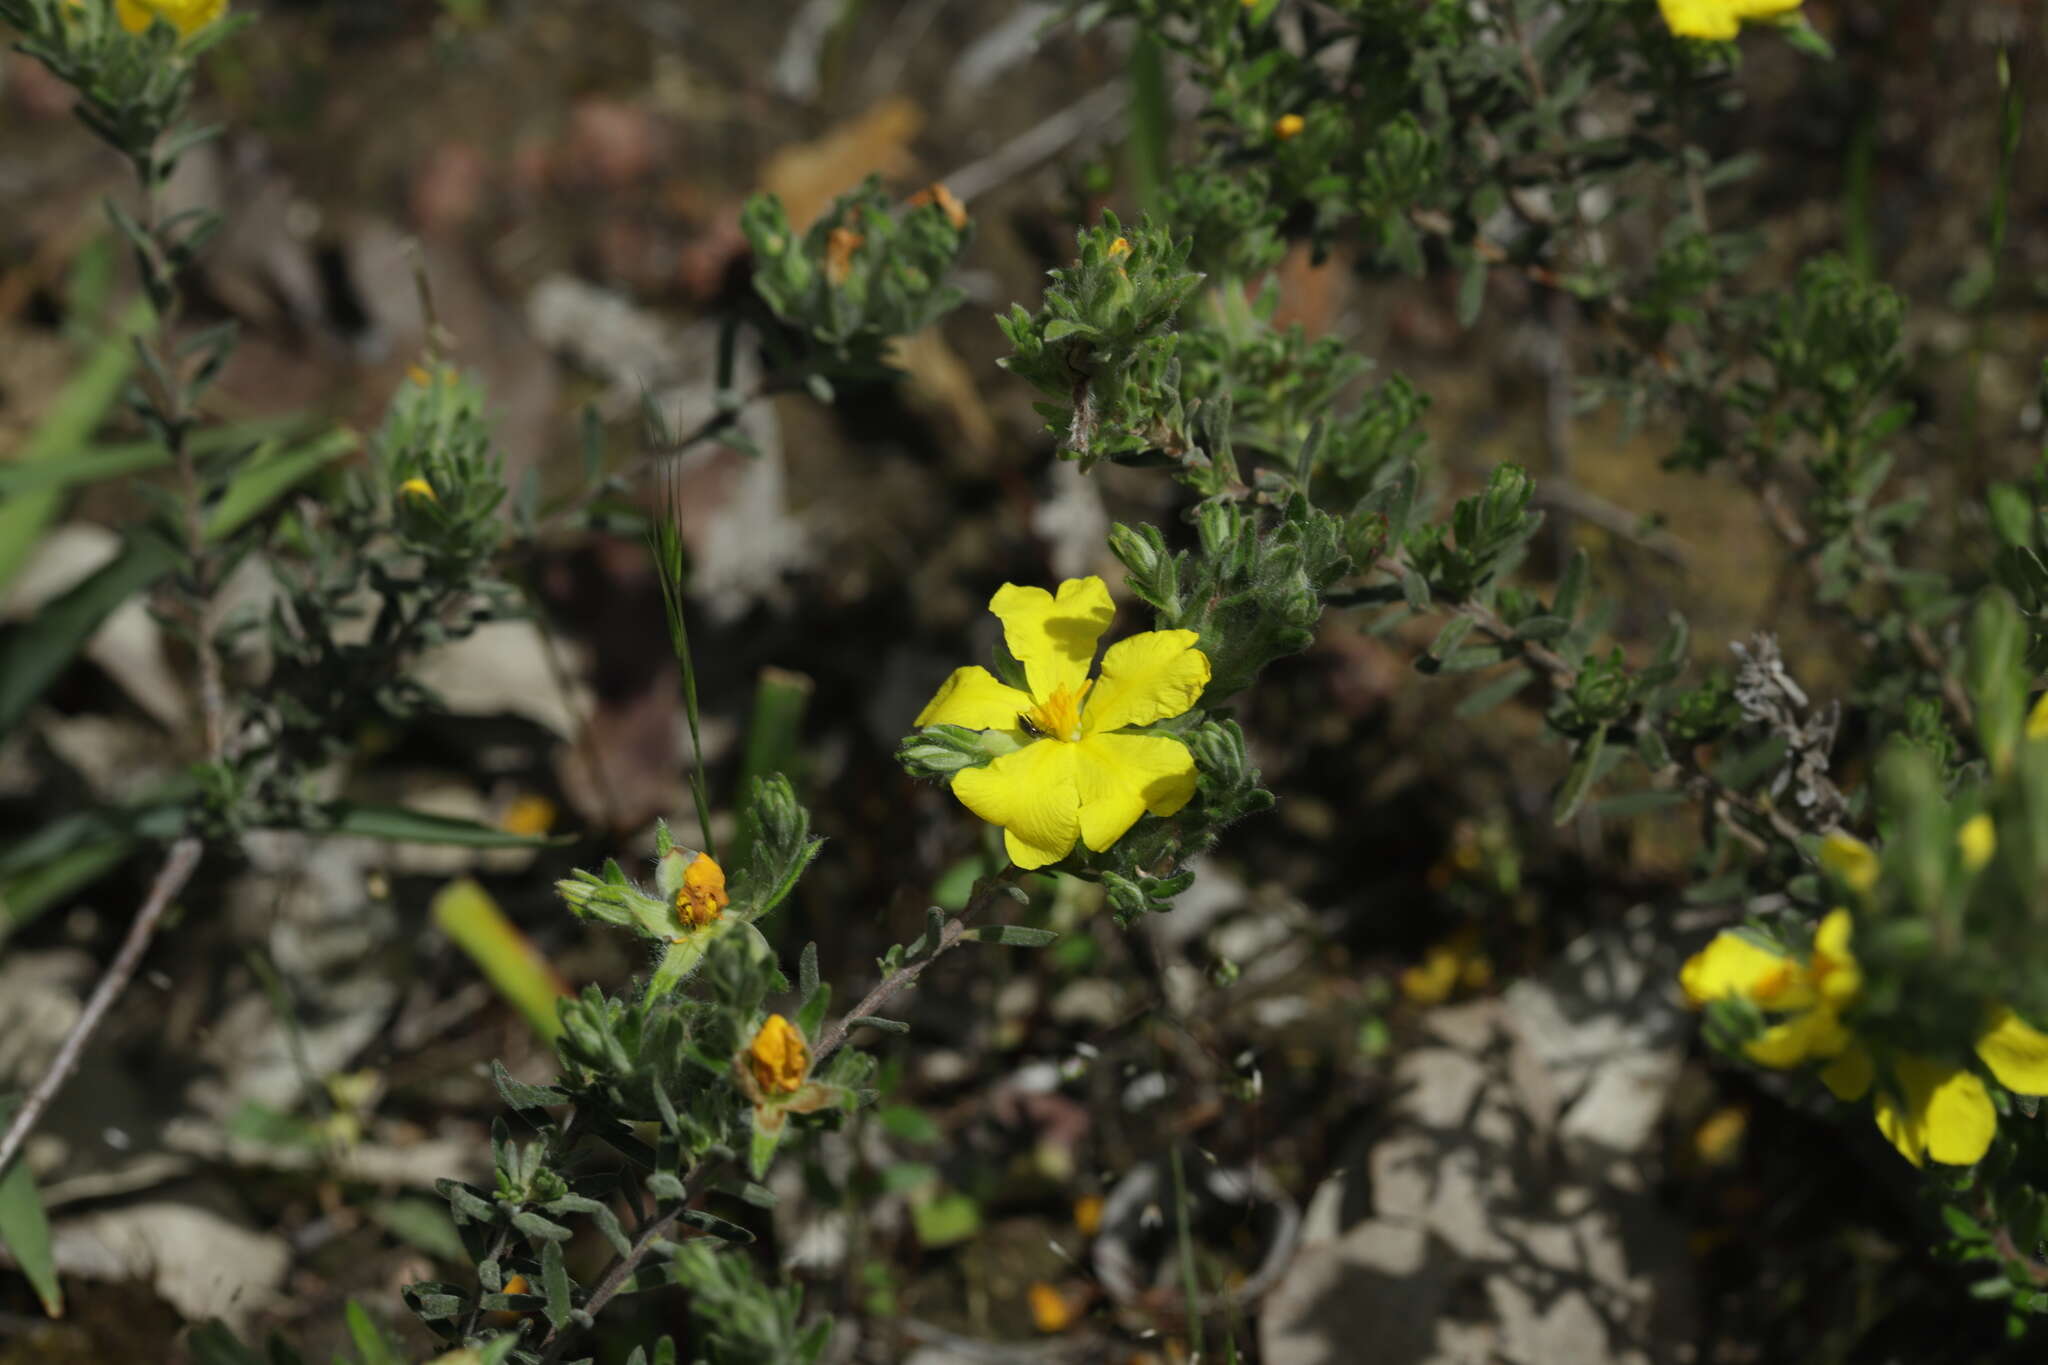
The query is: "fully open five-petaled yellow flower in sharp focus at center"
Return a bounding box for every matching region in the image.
[918,577,1208,868]
